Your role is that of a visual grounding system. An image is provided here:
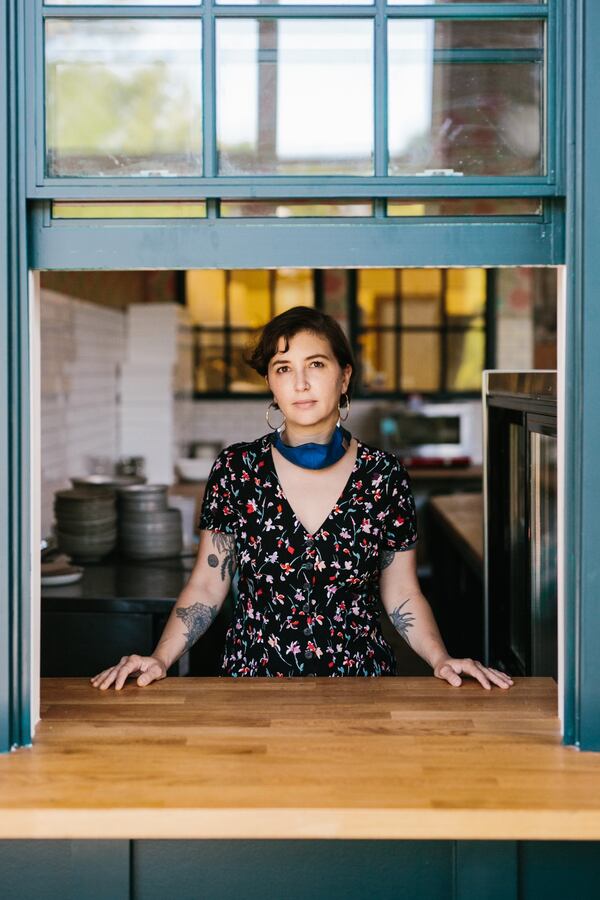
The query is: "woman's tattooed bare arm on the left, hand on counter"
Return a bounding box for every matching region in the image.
[90,531,237,690]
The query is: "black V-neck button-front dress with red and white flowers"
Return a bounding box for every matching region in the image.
[199,434,417,677]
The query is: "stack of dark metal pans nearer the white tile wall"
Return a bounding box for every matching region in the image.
[54,488,117,562]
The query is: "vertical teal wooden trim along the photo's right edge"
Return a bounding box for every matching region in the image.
[564,0,600,751]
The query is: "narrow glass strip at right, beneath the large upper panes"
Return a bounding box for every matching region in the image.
[387,197,542,217]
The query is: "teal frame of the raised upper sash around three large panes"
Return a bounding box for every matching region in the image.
[25,0,564,202]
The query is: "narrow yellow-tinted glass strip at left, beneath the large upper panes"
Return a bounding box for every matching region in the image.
[52,200,206,219]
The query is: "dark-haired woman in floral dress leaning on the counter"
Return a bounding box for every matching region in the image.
[91,306,512,690]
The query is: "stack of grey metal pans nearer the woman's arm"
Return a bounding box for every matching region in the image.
[117,484,183,559]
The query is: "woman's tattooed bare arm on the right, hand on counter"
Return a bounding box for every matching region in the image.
[379,549,513,690]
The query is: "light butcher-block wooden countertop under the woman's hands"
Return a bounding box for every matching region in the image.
[0,676,600,840]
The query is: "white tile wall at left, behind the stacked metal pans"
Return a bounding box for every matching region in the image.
[41,290,125,535]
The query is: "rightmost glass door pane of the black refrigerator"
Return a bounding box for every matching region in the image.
[530,432,558,678]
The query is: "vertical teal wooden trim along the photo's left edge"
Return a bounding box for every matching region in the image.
[0,0,31,752]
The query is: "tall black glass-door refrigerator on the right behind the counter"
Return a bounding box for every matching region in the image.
[483,371,558,679]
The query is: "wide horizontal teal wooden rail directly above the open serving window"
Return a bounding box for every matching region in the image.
[30,221,564,269]
